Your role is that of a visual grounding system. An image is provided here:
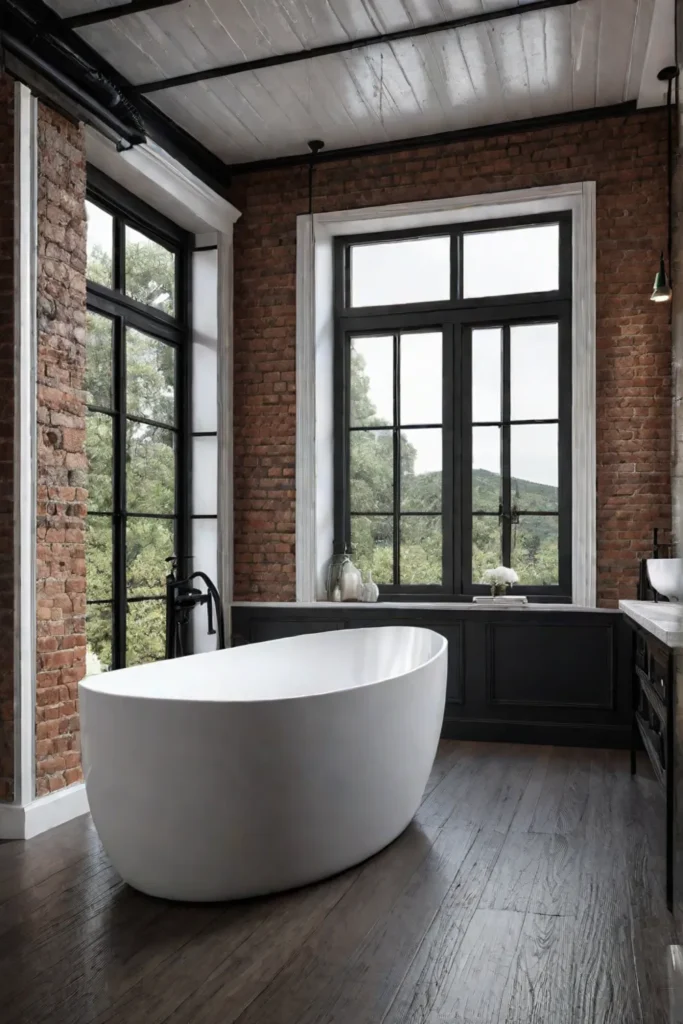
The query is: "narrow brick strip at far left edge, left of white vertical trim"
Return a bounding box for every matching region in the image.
[0,75,14,801]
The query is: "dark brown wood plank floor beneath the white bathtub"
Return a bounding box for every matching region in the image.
[0,741,675,1024]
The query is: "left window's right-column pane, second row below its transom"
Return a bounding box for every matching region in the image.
[126,423,175,515]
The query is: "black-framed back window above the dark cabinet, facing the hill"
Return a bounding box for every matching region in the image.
[334,213,571,601]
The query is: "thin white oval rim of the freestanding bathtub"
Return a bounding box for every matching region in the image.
[78,624,449,707]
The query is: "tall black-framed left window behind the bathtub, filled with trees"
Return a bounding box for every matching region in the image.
[85,168,190,672]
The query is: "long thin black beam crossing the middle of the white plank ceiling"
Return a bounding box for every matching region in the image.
[134,0,579,95]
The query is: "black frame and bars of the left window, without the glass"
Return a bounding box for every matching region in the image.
[86,165,194,670]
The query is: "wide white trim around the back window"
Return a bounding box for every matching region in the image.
[296,181,597,608]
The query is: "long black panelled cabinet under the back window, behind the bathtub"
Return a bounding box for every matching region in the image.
[231,603,631,748]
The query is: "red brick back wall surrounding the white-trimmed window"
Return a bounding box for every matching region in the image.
[232,111,671,605]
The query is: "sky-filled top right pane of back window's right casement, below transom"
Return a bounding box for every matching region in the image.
[510,324,559,420]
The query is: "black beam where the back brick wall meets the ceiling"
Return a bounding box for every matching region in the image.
[228,99,651,177]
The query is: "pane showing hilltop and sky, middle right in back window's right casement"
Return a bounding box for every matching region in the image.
[510,423,558,512]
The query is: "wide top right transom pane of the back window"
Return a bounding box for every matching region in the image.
[463,224,560,299]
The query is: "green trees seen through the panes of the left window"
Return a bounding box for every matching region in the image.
[85,241,175,672]
